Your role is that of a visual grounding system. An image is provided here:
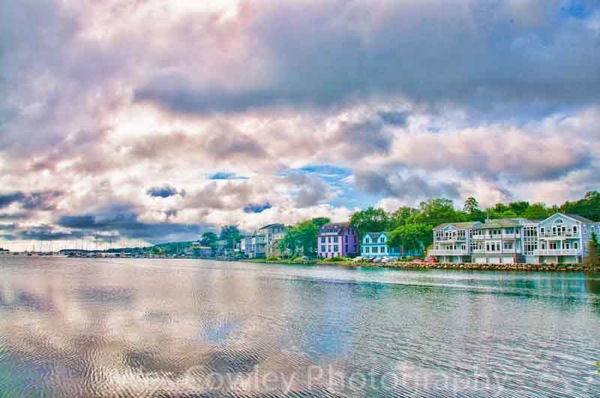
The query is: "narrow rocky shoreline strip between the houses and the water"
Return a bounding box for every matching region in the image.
[241,258,600,272]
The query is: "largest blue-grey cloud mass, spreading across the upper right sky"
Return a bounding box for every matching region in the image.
[135,0,600,114]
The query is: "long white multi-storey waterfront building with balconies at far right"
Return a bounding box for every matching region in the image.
[429,213,600,264]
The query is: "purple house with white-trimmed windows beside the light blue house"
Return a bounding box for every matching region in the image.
[317,223,358,258]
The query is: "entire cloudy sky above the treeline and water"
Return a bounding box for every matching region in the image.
[0,0,600,250]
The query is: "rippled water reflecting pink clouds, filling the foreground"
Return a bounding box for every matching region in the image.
[0,257,600,397]
